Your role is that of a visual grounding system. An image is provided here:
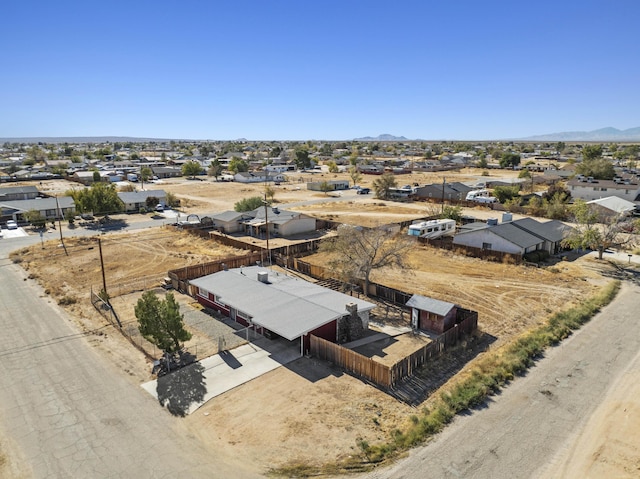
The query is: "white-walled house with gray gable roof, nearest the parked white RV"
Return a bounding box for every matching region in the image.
[453,223,545,256]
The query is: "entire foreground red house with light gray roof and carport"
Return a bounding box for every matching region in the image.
[190,266,375,355]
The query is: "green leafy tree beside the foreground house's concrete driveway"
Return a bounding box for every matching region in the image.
[134,291,191,353]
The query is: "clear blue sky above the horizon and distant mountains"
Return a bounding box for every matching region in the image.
[0,0,640,140]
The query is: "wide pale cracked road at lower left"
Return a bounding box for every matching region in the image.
[0,248,260,478]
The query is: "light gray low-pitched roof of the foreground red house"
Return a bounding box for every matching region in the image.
[190,266,375,341]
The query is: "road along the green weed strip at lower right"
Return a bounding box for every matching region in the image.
[367,284,640,479]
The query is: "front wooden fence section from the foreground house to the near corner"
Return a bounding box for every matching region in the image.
[311,335,392,388]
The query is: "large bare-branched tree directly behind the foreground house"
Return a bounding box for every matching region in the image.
[321,225,414,295]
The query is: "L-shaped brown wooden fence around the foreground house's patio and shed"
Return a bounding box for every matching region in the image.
[311,310,478,389]
